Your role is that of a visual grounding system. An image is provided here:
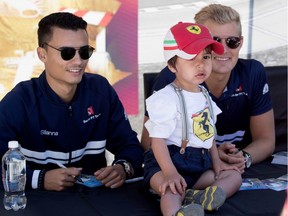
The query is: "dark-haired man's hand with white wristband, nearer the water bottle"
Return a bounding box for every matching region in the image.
[44,167,82,191]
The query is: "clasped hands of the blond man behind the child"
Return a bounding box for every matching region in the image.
[218,143,245,173]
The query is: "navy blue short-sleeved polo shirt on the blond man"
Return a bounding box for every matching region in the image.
[146,59,272,148]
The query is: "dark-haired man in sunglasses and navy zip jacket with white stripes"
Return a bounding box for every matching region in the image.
[0,12,143,191]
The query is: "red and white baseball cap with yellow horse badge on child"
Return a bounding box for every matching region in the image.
[164,22,224,61]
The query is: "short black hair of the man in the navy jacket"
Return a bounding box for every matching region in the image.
[37,12,87,47]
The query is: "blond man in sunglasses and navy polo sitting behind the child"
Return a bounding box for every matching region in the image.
[141,4,275,172]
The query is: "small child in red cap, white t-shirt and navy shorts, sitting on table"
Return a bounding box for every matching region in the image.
[144,22,242,216]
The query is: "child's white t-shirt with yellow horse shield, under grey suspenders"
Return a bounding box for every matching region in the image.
[145,85,221,149]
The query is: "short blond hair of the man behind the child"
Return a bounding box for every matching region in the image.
[194,4,242,36]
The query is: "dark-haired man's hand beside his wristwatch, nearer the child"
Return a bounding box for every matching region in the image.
[94,164,126,188]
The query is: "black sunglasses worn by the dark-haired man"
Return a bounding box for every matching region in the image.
[42,43,94,61]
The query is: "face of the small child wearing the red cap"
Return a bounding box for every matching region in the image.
[168,50,212,91]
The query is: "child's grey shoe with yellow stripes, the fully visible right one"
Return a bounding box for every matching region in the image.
[184,186,226,211]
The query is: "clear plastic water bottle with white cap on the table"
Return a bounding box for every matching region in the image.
[2,141,27,211]
